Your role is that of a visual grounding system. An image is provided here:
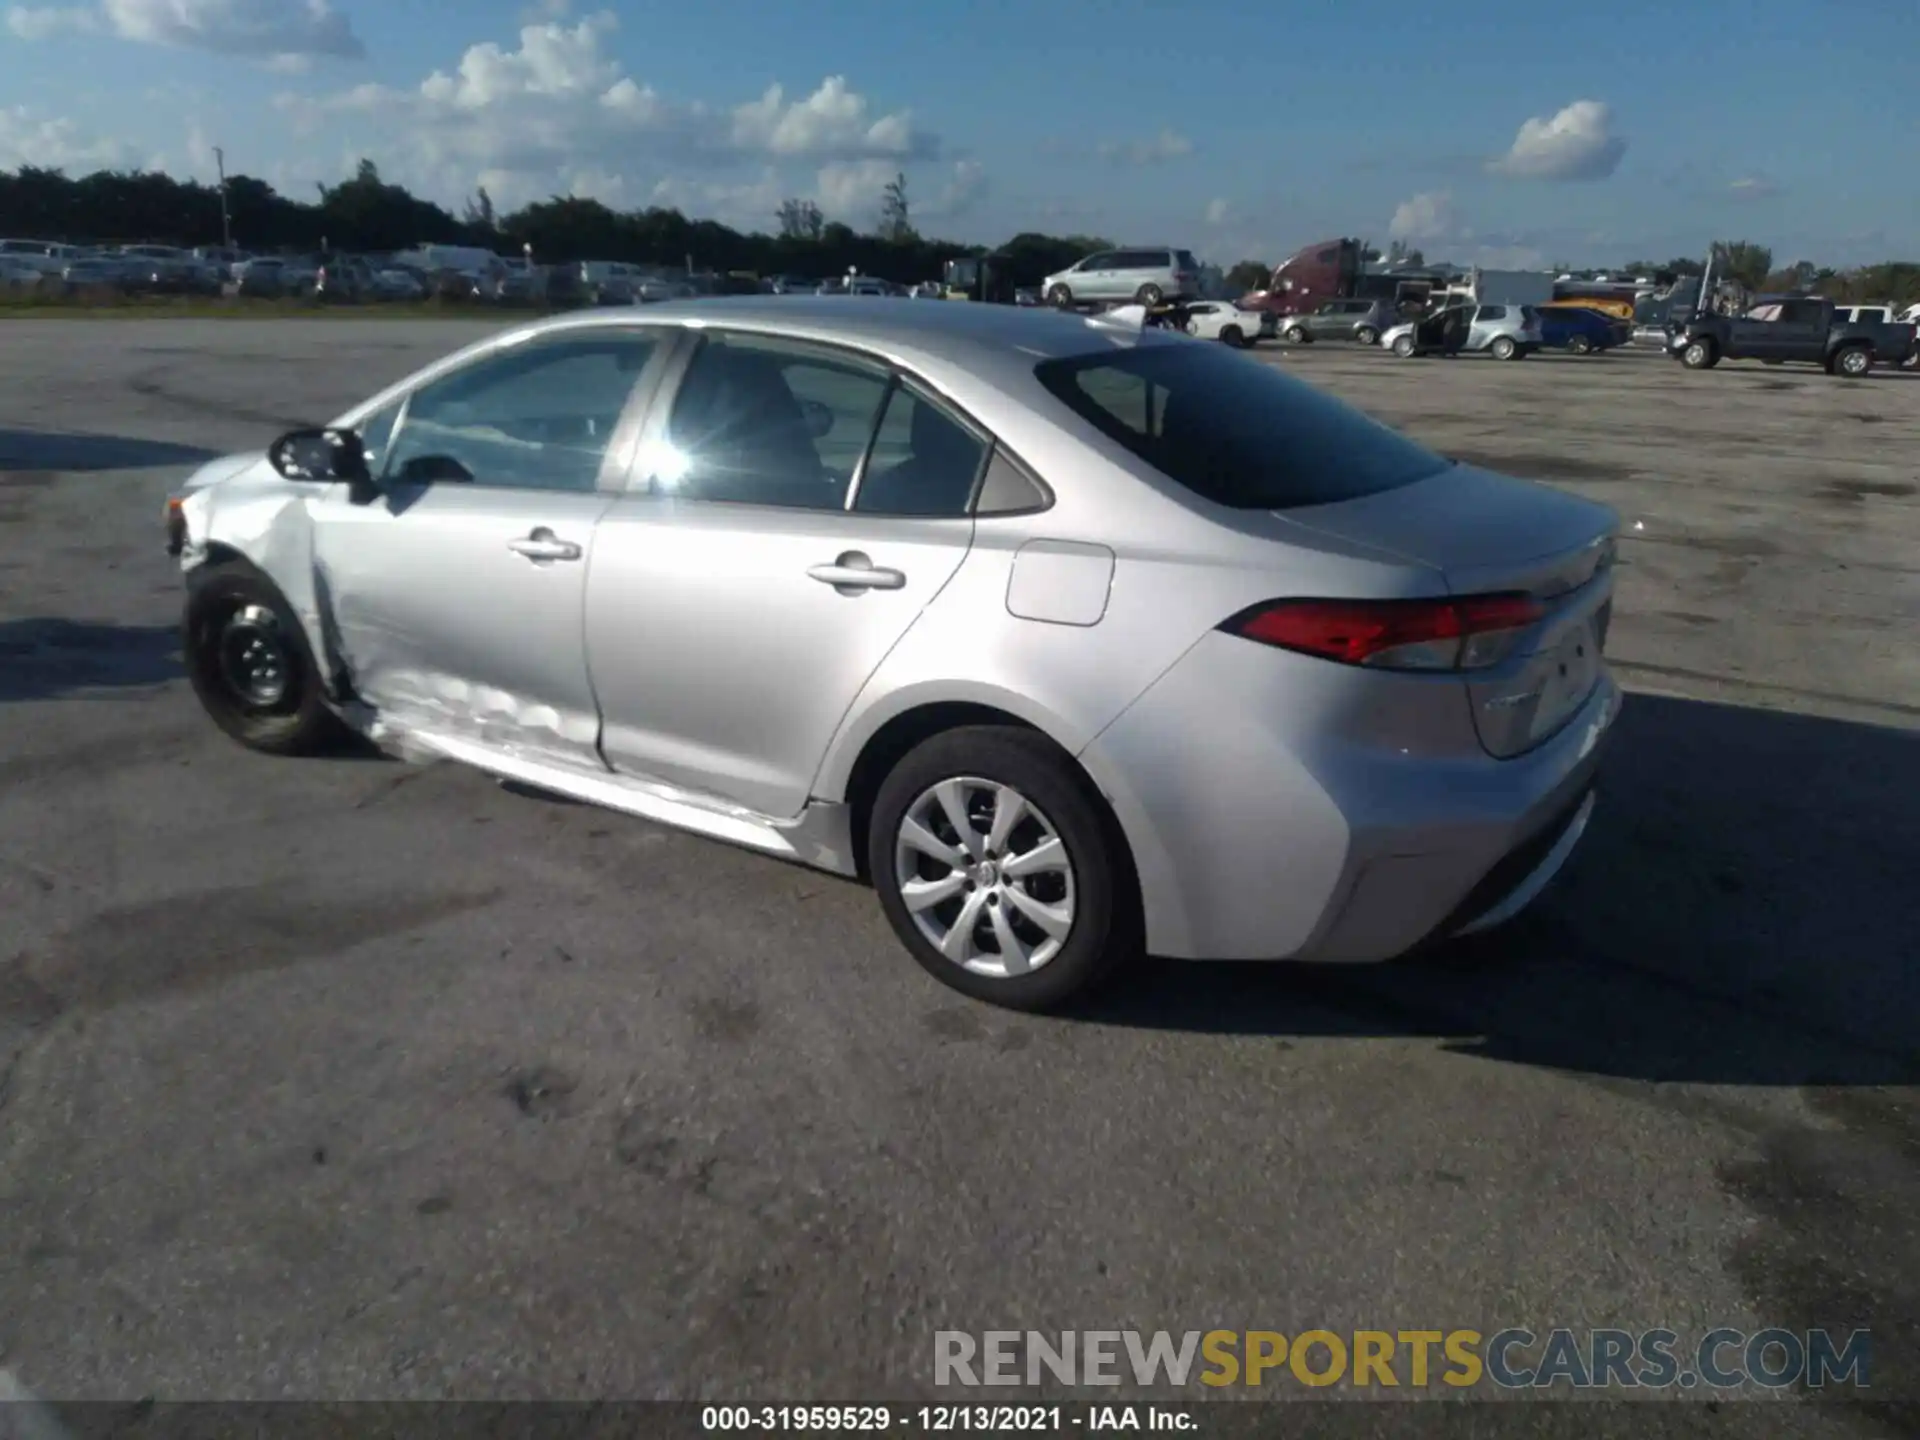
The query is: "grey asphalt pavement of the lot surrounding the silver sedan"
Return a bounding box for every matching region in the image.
[0,321,1920,1436]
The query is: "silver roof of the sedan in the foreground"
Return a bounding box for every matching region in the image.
[495,296,1181,380]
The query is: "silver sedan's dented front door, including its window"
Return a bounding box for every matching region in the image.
[313,326,674,770]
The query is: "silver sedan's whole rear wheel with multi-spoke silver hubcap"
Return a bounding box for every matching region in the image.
[868,726,1140,1010]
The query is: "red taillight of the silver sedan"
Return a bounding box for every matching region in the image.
[1221,595,1546,670]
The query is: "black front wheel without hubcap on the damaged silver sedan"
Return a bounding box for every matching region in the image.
[180,561,348,755]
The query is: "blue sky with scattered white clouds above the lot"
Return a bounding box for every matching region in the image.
[0,0,1920,265]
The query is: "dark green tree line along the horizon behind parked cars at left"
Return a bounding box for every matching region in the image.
[0,159,1114,284]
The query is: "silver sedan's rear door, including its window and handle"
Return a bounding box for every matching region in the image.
[588,330,989,820]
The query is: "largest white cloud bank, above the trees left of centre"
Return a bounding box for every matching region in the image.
[276,13,939,211]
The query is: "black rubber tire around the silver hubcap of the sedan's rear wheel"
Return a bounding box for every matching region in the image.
[866,726,1140,1010]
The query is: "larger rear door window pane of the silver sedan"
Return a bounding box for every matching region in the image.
[668,334,889,511]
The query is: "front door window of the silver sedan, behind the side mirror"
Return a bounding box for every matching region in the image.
[384,330,659,492]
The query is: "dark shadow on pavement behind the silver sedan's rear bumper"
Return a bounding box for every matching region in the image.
[1079,695,1920,1085]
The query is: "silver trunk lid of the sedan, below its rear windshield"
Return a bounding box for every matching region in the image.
[1284,465,1619,756]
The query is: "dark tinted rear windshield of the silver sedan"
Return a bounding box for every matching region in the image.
[1035,344,1448,511]
